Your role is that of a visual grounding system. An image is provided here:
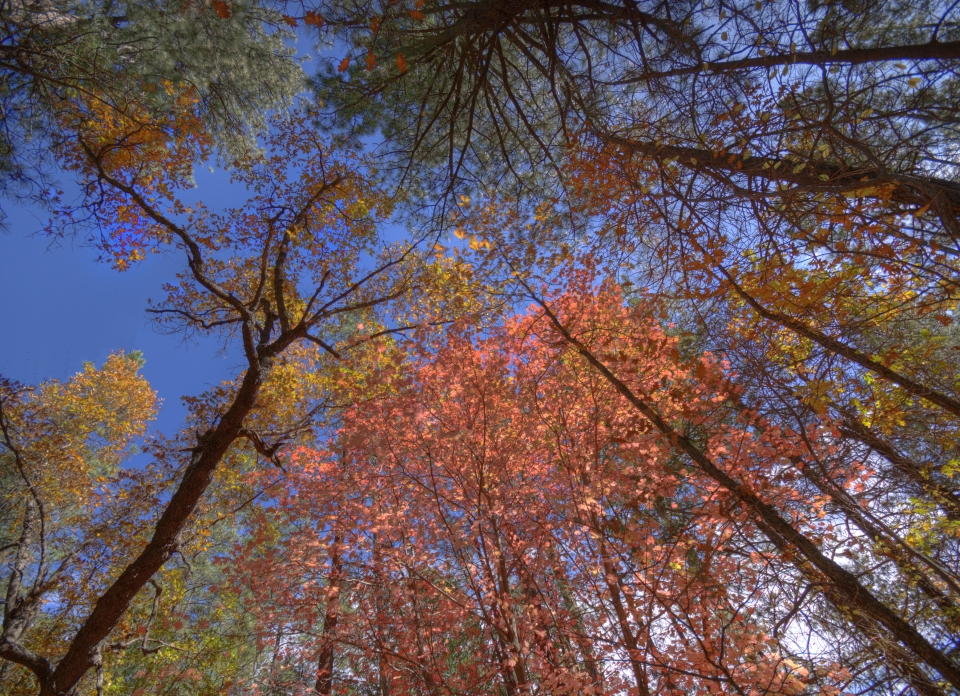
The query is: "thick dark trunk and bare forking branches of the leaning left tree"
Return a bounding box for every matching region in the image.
[0,133,411,696]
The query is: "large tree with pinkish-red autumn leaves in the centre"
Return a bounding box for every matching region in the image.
[231,276,900,694]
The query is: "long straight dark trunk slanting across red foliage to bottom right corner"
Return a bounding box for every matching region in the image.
[526,287,960,688]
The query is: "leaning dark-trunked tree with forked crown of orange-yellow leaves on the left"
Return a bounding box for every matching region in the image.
[0,85,442,694]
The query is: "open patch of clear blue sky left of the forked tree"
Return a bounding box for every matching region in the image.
[0,167,248,434]
